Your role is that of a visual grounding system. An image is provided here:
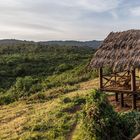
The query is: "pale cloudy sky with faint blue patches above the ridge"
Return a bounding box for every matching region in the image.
[0,0,140,41]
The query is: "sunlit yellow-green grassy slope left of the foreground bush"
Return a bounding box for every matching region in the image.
[0,79,98,140]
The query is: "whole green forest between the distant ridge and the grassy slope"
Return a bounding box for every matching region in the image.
[0,41,95,104]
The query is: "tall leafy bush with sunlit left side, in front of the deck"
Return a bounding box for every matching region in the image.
[84,91,121,140]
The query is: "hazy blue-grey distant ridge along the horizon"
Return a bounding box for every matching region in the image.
[0,39,102,49]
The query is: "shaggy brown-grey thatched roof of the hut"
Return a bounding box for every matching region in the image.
[90,30,140,71]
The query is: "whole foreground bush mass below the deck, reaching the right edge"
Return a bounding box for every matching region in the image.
[83,91,140,140]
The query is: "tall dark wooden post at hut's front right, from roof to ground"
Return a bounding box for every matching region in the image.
[131,69,136,109]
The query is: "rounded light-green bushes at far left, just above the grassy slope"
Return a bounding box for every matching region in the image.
[0,76,42,104]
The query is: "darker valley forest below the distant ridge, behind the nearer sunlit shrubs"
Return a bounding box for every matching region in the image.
[0,42,94,90]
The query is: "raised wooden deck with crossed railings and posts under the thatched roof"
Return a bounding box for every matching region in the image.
[99,68,140,109]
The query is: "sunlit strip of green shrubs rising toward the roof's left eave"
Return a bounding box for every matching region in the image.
[45,64,97,88]
